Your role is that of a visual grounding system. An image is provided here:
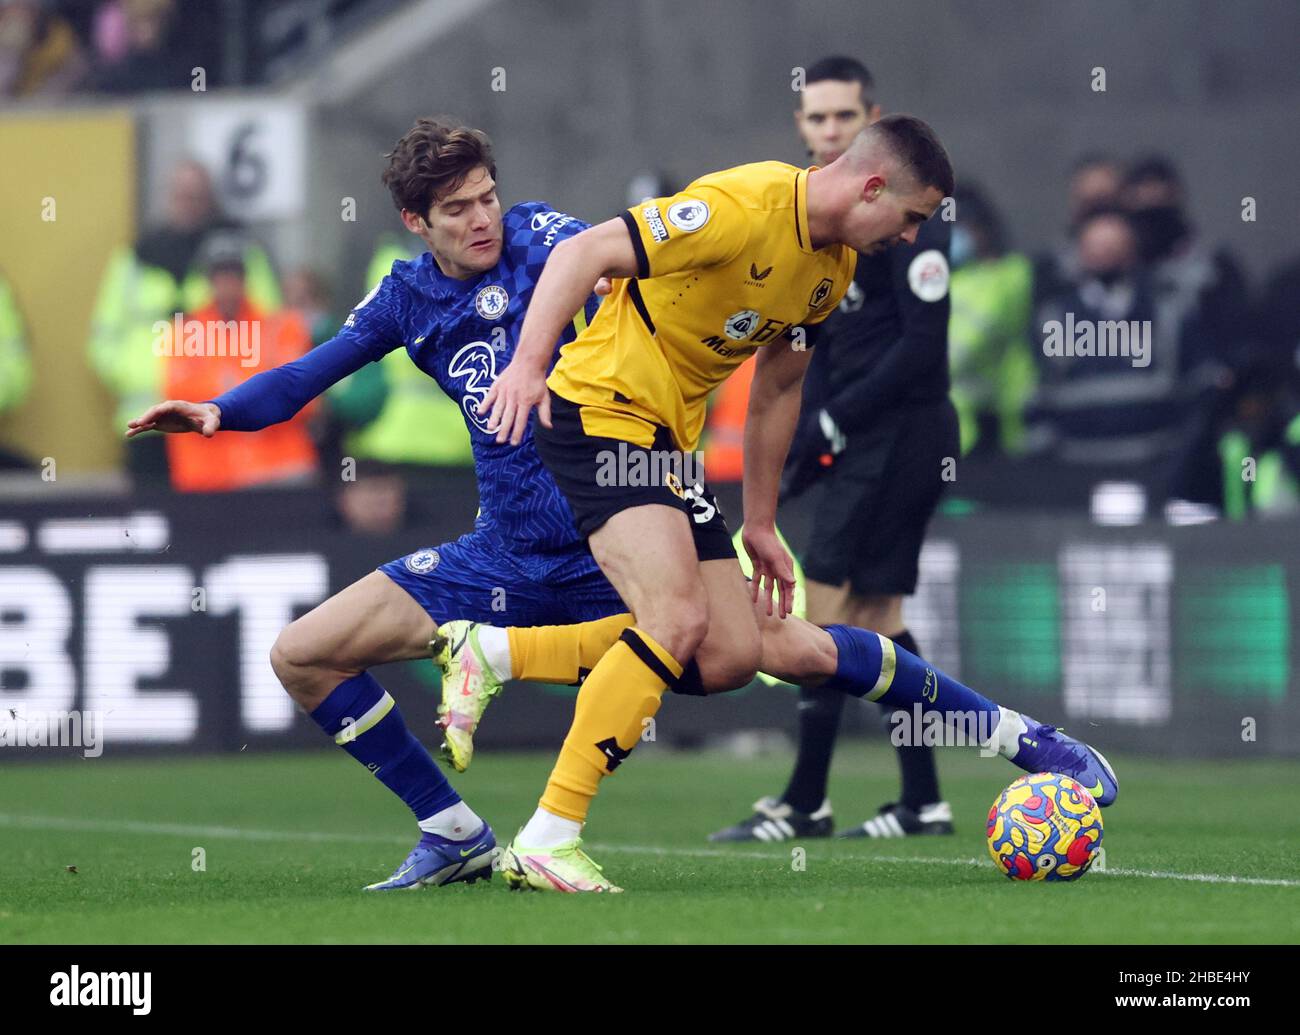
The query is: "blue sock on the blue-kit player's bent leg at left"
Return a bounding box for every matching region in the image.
[312,672,460,819]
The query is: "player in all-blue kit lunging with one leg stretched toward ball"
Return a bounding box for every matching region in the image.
[127,113,1117,891]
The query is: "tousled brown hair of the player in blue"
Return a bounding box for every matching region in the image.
[382,116,497,216]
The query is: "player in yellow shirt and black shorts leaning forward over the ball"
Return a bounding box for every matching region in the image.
[480,116,953,891]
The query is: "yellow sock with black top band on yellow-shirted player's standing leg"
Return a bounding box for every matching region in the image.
[540,625,681,823]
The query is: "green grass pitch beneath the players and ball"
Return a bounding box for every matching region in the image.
[0,742,1300,944]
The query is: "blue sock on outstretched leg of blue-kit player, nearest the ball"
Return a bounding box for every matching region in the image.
[824,625,1000,732]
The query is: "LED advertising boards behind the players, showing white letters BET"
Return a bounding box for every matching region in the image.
[0,472,1300,762]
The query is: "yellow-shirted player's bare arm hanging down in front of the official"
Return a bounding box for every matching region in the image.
[741,341,813,618]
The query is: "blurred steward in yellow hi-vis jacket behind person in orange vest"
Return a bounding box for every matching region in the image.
[90,161,280,481]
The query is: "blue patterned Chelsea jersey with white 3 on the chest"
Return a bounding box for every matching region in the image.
[337,202,598,553]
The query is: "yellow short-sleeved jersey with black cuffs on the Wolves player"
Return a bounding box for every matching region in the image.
[547,161,857,450]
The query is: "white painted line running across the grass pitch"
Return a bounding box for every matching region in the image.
[0,813,1300,888]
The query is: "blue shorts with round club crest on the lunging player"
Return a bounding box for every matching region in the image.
[378,531,628,627]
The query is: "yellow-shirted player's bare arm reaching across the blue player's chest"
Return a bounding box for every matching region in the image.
[478,220,637,446]
